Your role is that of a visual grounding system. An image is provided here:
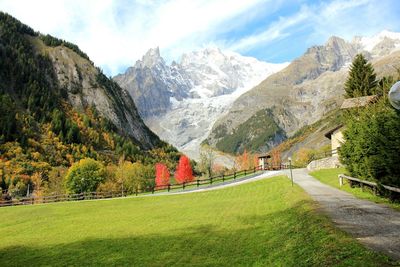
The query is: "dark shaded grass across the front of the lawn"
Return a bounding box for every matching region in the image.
[0,201,391,266]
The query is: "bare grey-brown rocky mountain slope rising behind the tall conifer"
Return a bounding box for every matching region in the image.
[207,31,400,154]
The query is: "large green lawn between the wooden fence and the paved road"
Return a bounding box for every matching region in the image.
[0,177,390,266]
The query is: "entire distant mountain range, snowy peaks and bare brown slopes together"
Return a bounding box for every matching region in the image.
[114,31,400,161]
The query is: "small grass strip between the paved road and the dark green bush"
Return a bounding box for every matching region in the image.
[310,168,400,210]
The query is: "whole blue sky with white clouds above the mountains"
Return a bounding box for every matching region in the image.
[0,0,400,76]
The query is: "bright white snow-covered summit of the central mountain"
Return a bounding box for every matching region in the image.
[180,48,285,98]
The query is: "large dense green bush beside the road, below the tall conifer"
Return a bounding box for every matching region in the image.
[339,99,400,187]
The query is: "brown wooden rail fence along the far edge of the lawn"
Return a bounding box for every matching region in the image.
[0,165,287,207]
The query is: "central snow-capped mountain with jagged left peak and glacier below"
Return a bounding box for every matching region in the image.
[114,48,288,158]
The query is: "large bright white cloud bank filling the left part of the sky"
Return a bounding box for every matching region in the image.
[0,0,265,75]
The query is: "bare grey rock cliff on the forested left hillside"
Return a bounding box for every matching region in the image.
[31,37,160,149]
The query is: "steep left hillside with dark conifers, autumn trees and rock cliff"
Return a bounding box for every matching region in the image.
[0,12,179,199]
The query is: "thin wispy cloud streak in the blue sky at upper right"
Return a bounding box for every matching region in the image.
[226,0,400,55]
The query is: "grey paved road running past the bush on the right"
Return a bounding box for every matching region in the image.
[285,169,400,260]
